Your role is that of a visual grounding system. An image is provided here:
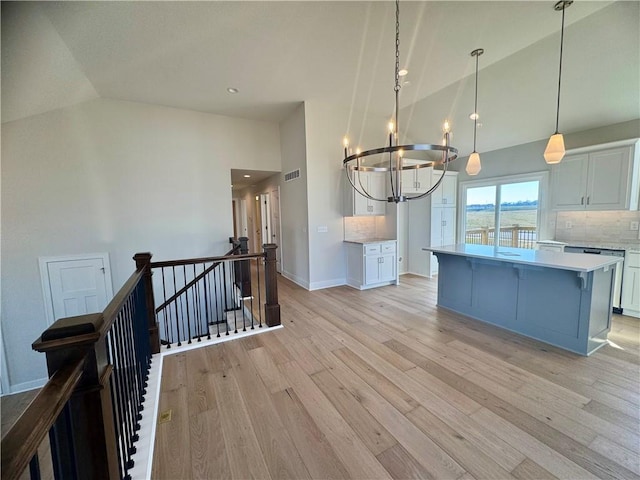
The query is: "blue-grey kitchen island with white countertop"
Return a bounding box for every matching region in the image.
[423,244,621,355]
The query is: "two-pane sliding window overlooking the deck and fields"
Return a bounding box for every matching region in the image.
[460,172,548,248]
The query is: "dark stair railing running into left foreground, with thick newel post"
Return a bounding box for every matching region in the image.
[1,253,160,480]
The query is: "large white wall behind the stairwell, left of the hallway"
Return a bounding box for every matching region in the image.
[2,100,281,389]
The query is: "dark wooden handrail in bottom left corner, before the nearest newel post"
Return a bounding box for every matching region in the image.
[1,355,87,480]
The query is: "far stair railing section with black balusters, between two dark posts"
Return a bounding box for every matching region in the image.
[150,237,280,348]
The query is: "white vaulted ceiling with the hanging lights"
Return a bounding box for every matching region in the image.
[2,1,640,158]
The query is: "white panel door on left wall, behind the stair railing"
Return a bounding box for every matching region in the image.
[40,254,113,325]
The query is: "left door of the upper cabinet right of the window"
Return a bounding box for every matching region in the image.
[551,153,589,210]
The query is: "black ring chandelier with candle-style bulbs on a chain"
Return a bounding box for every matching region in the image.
[342,0,458,203]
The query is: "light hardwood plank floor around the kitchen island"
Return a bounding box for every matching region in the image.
[153,275,640,479]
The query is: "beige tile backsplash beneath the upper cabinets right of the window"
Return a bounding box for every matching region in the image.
[555,210,640,247]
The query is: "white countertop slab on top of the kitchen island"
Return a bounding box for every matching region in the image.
[422,243,623,272]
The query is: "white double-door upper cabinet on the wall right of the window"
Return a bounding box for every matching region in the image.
[551,141,639,210]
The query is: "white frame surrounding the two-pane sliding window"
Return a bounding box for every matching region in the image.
[457,171,549,246]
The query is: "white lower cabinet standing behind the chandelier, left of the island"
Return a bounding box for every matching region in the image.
[346,240,397,290]
